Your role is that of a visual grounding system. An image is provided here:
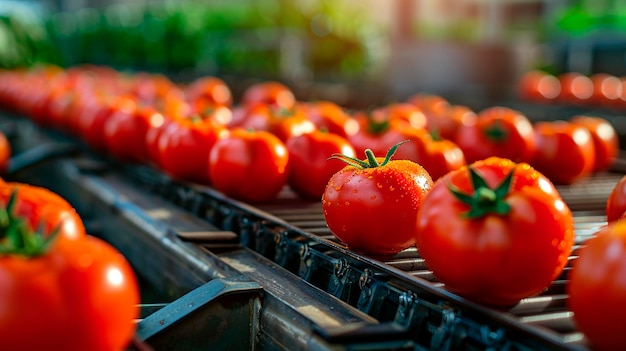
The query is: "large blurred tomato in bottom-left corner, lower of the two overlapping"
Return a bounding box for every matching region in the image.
[0,236,140,351]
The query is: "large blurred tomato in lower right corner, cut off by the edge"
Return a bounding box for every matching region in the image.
[566,220,626,350]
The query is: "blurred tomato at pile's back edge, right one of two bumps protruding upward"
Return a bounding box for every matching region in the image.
[241,81,296,109]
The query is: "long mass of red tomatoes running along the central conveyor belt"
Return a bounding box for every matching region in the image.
[0,66,619,350]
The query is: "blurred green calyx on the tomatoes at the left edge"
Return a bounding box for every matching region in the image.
[0,190,60,257]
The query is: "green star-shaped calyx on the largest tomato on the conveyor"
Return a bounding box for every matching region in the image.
[448,167,515,219]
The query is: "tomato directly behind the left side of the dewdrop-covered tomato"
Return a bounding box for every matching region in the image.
[286,130,356,200]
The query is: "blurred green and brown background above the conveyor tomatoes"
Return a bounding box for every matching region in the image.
[0,0,626,106]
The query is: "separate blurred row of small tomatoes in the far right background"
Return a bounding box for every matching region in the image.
[517,70,626,110]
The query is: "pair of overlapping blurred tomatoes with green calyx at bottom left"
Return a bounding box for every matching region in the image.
[0,181,140,351]
